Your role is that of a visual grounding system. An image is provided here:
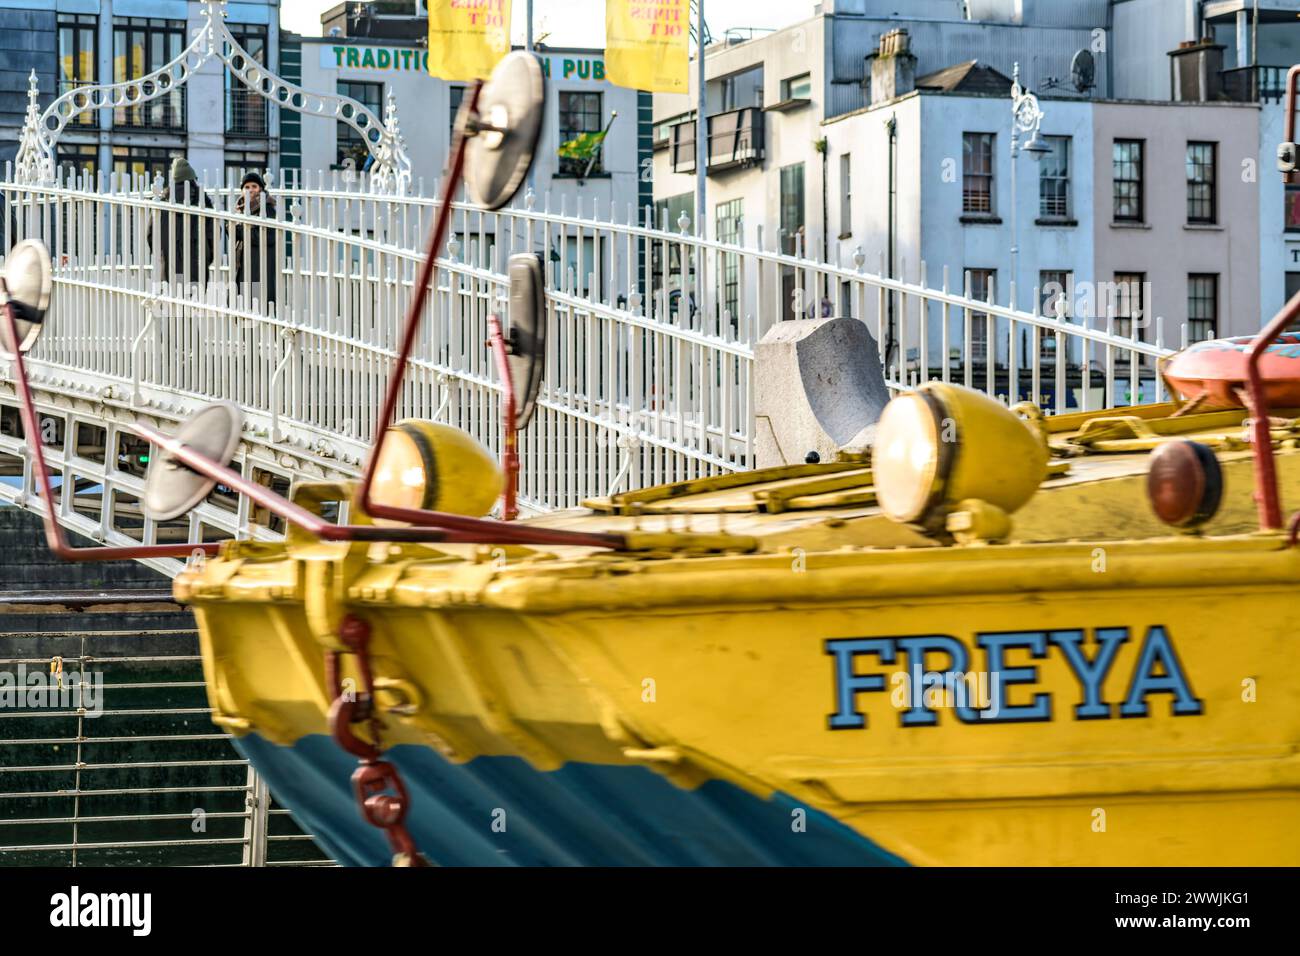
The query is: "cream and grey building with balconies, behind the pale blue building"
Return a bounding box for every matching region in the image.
[654,0,1108,251]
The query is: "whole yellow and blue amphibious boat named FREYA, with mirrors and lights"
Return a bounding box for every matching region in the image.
[5,53,1300,865]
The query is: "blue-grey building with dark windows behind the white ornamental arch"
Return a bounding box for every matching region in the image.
[0,0,280,179]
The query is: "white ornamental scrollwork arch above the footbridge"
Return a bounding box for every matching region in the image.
[16,0,411,193]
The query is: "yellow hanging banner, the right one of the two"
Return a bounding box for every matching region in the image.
[605,0,690,92]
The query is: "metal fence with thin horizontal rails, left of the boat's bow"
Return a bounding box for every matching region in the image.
[0,591,330,866]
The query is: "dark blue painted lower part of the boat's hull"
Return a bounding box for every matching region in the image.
[235,734,906,866]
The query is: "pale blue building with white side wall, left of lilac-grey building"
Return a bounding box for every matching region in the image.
[823,78,1095,385]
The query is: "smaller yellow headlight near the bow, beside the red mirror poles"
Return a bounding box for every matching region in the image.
[371,419,504,518]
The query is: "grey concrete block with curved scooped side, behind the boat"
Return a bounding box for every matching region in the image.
[754,319,889,468]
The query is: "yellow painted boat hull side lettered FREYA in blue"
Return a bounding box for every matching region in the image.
[178,536,1300,866]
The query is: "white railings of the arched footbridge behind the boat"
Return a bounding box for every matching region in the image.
[0,169,1186,572]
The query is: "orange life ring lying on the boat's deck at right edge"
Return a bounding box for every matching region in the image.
[1162,332,1300,410]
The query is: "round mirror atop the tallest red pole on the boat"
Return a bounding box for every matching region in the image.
[462,49,546,209]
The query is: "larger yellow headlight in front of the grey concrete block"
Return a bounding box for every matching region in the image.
[871,382,1048,527]
